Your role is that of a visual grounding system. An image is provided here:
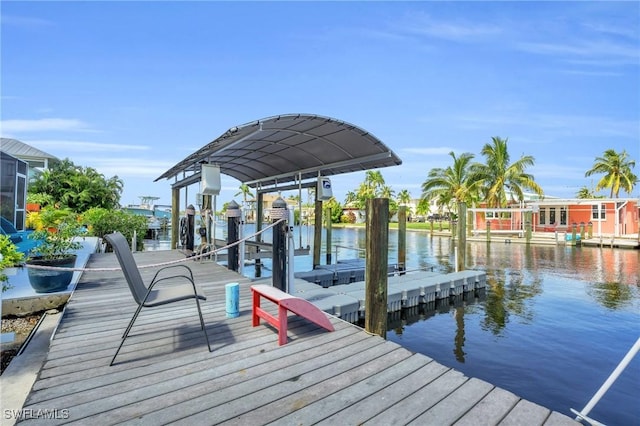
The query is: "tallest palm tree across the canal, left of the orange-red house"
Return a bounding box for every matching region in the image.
[474,136,544,207]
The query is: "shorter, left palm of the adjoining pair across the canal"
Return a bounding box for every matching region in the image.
[422,151,480,205]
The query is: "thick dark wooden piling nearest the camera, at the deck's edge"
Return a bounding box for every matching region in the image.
[364,198,389,338]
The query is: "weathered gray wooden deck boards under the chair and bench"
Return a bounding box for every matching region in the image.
[17,251,576,426]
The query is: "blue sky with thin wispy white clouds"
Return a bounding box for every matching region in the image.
[0,2,640,205]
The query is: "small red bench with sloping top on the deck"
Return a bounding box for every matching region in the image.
[251,284,334,345]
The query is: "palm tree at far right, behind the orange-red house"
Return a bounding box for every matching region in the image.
[584,149,638,198]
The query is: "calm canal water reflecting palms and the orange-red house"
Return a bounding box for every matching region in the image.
[149,225,640,425]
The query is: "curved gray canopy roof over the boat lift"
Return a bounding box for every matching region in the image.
[155,114,402,187]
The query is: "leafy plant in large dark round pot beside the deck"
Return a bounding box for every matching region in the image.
[25,214,83,293]
